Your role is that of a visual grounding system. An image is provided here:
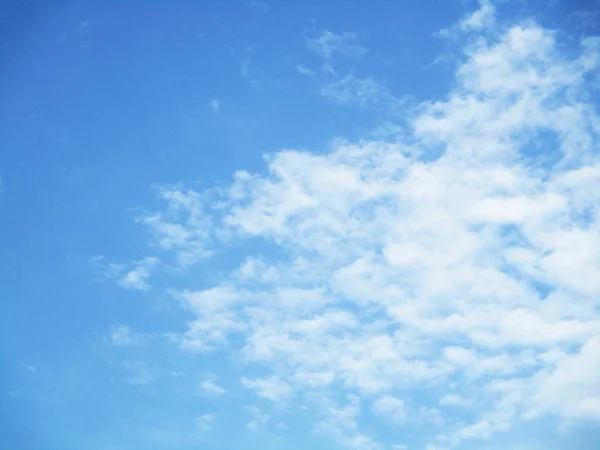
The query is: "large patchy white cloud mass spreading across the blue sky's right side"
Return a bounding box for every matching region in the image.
[105,3,600,449]
